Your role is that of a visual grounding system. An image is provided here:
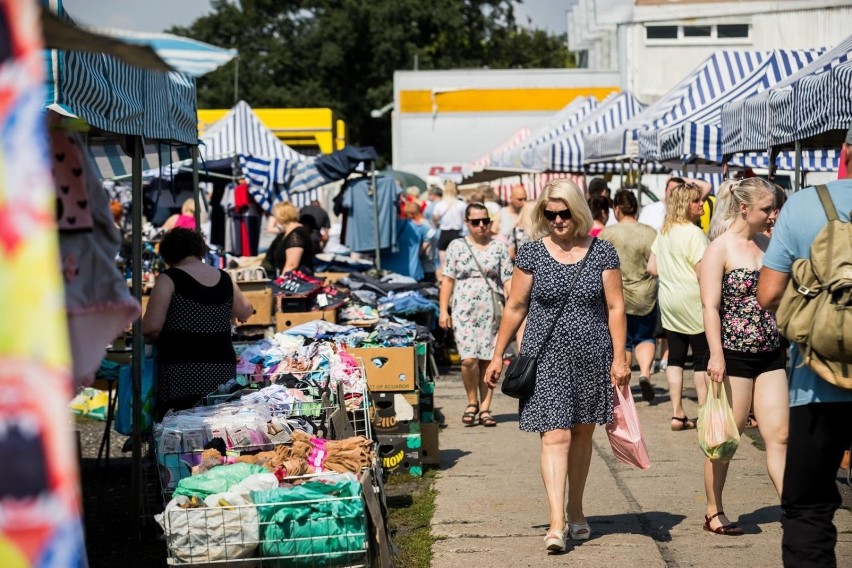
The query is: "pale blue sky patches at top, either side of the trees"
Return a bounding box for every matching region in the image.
[63,0,568,33]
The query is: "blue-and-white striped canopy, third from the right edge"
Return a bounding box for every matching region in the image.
[586,51,784,161]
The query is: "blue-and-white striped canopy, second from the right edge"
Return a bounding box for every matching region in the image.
[652,49,825,163]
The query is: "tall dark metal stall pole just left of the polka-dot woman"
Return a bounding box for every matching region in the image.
[130,136,145,565]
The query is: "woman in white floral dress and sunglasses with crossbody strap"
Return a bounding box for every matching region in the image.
[438,203,512,426]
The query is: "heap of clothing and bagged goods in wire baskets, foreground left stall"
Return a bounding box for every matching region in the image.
[155,340,383,567]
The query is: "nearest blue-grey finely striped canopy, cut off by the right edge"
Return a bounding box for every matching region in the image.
[721,36,852,154]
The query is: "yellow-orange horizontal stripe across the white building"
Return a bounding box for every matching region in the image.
[399,87,619,113]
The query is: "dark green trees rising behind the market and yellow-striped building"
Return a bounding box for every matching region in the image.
[169,0,573,158]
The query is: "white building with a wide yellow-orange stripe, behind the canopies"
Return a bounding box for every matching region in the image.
[391,69,619,181]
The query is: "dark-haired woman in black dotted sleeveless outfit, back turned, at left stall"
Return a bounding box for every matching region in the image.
[142,229,252,420]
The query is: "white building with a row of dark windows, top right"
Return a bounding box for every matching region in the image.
[566,0,852,104]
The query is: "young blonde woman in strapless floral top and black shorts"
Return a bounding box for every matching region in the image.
[698,177,788,536]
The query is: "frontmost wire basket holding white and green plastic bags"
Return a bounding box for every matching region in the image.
[158,474,369,568]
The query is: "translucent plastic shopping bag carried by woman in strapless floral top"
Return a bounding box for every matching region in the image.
[698,379,740,461]
